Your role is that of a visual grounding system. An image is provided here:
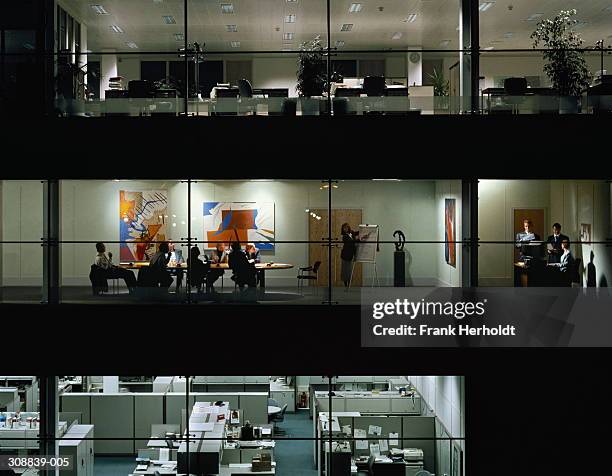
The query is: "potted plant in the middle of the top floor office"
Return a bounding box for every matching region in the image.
[296,36,327,115]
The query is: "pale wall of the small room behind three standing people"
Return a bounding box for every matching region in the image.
[478,180,612,286]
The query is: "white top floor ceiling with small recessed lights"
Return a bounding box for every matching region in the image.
[60,0,612,53]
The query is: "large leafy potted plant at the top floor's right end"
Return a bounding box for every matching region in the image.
[531,9,591,113]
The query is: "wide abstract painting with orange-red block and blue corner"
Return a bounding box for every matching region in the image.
[203,202,274,250]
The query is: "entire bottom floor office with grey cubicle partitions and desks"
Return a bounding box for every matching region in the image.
[0,375,466,476]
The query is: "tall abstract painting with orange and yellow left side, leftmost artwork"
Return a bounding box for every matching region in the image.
[119,190,168,262]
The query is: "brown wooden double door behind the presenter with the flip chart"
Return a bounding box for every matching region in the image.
[308,208,363,287]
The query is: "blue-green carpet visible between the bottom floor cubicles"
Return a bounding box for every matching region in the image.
[94,411,317,476]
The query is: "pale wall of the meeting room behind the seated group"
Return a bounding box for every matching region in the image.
[2,180,461,286]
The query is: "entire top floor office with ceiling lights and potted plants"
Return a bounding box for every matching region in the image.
[0,0,612,117]
